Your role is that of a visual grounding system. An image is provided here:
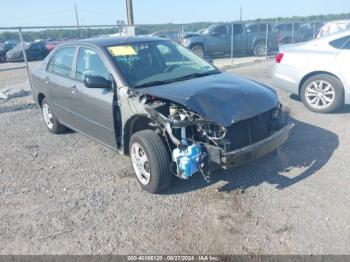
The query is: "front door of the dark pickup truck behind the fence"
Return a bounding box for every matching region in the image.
[207,25,230,53]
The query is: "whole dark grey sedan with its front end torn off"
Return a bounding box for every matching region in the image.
[32,37,293,193]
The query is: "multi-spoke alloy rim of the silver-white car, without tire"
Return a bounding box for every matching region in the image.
[305,80,335,109]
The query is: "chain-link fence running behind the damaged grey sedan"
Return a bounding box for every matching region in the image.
[0,21,323,99]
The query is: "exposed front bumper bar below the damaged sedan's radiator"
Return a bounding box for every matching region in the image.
[207,124,294,169]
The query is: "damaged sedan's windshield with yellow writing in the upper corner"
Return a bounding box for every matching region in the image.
[108,41,220,88]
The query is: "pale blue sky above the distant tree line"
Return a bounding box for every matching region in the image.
[0,0,350,27]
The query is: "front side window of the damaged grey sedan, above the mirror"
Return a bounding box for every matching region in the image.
[76,47,109,82]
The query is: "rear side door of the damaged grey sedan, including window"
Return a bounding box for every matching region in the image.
[42,46,76,127]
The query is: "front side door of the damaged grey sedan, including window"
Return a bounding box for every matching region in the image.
[72,47,117,148]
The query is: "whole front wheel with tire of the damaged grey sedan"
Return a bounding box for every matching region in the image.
[129,130,172,194]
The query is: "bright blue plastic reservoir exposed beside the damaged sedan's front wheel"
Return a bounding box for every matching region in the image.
[173,144,201,179]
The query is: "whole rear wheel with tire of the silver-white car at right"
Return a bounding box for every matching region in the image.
[300,74,344,113]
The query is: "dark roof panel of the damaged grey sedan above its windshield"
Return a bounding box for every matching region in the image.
[76,36,168,47]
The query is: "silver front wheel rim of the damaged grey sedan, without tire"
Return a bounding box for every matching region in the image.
[131,143,151,185]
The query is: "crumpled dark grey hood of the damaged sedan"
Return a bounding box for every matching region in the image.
[144,73,279,127]
